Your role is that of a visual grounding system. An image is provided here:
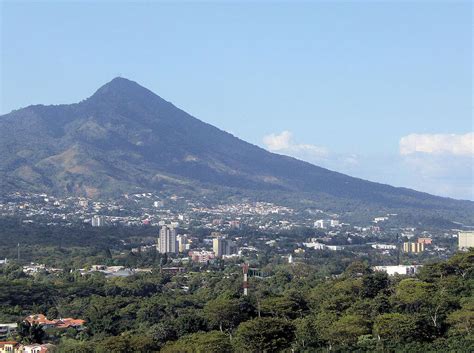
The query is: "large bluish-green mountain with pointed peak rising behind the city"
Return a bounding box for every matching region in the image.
[0,78,474,223]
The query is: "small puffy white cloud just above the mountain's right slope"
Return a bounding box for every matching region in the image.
[263,131,329,160]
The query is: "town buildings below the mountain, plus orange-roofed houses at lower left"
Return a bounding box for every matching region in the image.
[0,193,474,353]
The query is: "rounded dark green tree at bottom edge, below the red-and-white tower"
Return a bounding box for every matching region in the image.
[234,317,295,353]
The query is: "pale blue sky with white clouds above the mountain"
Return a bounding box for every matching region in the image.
[0,0,474,200]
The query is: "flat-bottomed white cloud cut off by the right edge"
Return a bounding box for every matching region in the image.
[399,132,474,156]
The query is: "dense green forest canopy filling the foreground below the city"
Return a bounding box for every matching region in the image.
[0,250,474,353]
